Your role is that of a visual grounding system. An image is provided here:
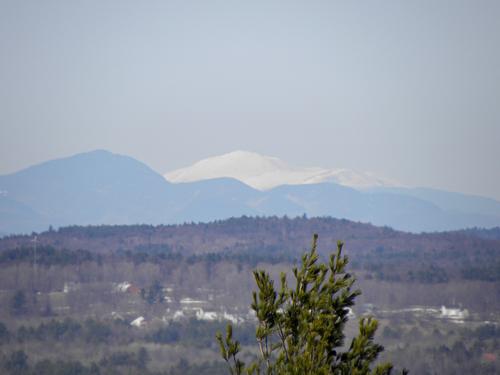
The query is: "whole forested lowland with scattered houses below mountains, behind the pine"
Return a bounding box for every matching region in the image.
[0,217,500,374]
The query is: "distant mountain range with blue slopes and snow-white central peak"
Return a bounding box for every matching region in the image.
[0,151,500,235]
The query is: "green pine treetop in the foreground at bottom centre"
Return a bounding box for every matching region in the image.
[217,234,407,375]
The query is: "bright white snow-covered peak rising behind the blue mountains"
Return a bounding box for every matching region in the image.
[165,151,398,190]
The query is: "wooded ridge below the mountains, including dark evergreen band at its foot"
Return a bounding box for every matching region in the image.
[0,217,500,283]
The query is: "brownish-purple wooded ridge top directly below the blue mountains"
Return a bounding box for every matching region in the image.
[0,216,500,262]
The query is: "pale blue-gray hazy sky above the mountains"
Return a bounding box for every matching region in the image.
[0,0,500,199]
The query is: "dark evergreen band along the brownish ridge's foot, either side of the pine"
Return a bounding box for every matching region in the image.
[0,245,500,284]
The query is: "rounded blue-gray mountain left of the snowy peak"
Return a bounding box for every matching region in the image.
[0,151,176,230]
